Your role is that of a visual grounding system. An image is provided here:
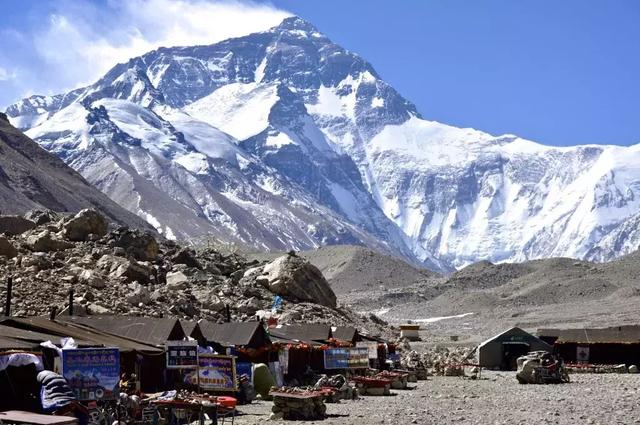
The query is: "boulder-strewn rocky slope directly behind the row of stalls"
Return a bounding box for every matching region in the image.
[0,210,388,334]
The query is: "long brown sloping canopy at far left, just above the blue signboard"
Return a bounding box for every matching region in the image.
[1,317,162,354]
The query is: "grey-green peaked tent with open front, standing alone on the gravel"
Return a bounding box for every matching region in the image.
[478,327,553,370]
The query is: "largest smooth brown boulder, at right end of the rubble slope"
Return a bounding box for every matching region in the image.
[256,254,337,308]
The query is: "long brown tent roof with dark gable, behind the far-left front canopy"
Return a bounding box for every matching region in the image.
[56,316,186,347]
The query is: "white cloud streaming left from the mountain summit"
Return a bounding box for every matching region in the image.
[0,0,290,102]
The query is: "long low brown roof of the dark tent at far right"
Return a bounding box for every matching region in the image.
[538,325,640,344]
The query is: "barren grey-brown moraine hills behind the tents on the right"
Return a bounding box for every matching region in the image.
[352,252,640,344]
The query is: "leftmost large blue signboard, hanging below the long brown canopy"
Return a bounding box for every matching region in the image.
[62,348,120,400]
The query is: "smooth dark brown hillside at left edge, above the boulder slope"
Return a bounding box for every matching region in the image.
[0,113,152,229]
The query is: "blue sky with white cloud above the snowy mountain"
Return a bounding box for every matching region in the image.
[0,0,640,145]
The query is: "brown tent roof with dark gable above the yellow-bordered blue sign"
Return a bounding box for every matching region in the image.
[198,320,271,348]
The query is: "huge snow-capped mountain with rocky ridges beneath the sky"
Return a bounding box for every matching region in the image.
[7,17,640,270]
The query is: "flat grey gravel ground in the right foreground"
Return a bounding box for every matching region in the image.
[235,372,640,425]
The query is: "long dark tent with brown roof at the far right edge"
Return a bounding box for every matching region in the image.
[538,325,640,365]
